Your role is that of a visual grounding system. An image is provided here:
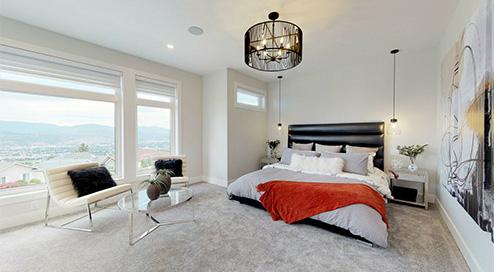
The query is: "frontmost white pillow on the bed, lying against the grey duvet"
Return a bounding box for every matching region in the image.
[289,153,345,175]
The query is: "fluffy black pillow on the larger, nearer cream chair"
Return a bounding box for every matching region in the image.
[67,167,117,197]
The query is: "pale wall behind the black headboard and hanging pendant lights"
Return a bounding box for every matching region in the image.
[268,47,438,194]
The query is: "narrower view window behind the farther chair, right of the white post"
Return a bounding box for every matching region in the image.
[136,76,176,174]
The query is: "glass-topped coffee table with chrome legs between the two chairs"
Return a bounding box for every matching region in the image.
[118,186,195,246]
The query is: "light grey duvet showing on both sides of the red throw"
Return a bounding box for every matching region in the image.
[227,168,388,247]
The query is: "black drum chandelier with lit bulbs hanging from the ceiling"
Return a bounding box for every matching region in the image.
[244,12,302,72]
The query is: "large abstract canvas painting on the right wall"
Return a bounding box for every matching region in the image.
[440,0,494,242]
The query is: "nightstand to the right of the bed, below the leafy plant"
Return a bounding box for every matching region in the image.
[391,168,429,210]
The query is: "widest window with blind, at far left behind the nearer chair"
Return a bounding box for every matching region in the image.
[0,46,122,189]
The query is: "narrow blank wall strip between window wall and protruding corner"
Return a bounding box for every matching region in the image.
[202,69,228,186]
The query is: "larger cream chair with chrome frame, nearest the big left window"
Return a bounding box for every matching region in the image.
[45,163,132,231]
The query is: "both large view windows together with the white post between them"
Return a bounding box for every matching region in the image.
[0,45,179,195]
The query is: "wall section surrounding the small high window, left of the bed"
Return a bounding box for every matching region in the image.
[228,69,268,182]
